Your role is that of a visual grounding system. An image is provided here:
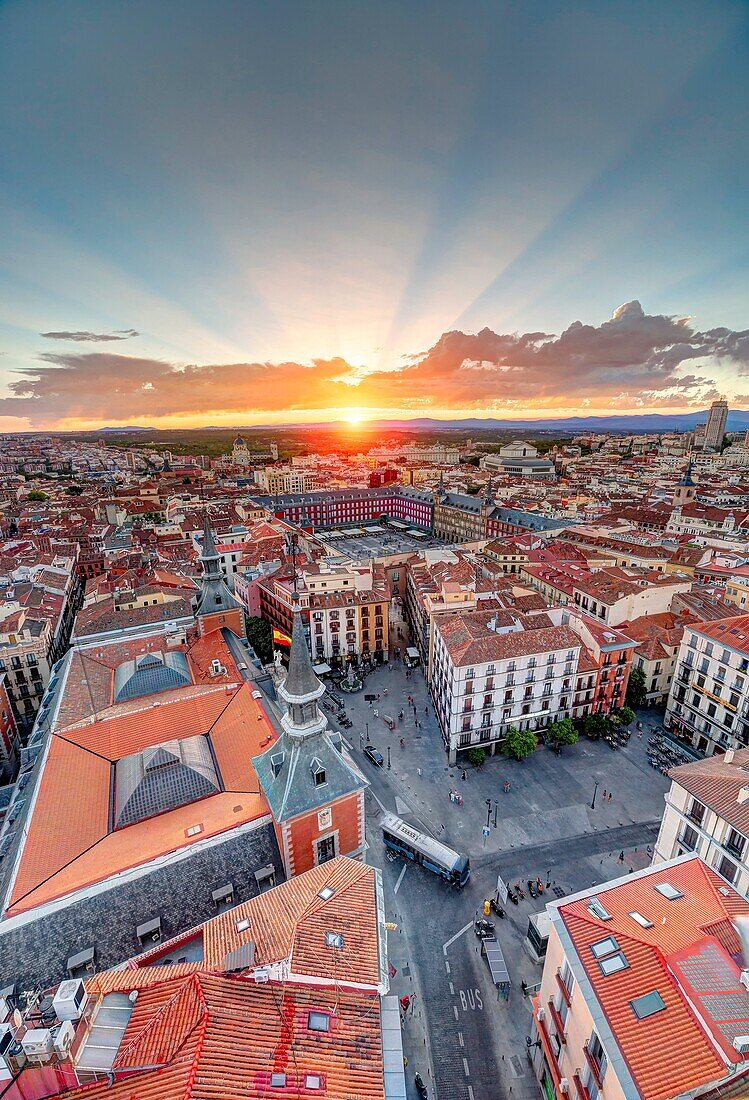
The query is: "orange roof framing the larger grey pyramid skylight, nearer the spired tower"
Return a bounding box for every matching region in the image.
[5,683,275,916]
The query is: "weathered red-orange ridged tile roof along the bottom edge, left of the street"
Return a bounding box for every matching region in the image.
[65,968,385,1100]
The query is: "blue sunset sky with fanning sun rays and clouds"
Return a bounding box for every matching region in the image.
[0,0,749,431]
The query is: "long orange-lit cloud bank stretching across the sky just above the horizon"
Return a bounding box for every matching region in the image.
[0,301,749,427]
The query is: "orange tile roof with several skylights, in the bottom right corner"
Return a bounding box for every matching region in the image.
[554,857,749,1100]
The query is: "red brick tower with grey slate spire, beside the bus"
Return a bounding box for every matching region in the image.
[252,609,368,878]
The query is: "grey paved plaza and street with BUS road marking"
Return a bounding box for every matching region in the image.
[327,662,668,1100]
